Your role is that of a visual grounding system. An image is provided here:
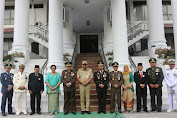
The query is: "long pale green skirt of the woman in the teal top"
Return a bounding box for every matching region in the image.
[48,93,59,113]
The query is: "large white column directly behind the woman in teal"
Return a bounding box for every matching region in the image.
[48,0,64,73]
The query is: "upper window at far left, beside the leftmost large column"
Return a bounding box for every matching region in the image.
[4,6,14,25]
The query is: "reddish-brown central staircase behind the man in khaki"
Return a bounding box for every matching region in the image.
[74,53,111,112]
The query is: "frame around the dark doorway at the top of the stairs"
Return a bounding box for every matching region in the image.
[76,33,102,54]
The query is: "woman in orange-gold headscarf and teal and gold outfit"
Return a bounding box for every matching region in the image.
[122,65,134,113]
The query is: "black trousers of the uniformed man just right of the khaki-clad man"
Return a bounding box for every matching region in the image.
[97,91,107,112]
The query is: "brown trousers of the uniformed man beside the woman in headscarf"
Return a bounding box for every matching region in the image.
[110,90,121,112]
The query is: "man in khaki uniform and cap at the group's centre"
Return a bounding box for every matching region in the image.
[77,61,93,114]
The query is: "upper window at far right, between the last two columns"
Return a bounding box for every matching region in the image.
[163,1,172,20]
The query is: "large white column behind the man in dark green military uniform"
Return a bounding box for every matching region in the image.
[147,0,167,57]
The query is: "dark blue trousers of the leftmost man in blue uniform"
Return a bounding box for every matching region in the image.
[1,91,13,113]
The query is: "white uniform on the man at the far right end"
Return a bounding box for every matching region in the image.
[164,68,177,111]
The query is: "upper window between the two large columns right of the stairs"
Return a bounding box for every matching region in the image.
[133,1,148,21]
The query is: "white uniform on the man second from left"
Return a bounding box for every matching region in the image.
[13,72,29,114]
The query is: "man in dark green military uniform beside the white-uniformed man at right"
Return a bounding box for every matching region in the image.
[146,58,164,112]
